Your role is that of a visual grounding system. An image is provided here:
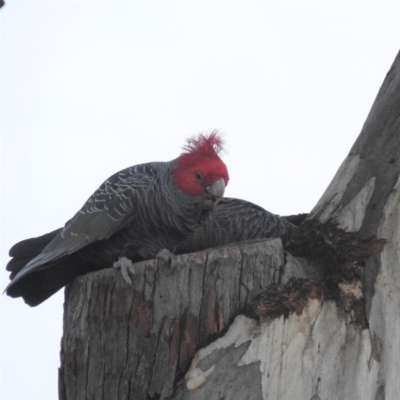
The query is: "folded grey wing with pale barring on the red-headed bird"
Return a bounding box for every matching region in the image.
[6,163,159,290]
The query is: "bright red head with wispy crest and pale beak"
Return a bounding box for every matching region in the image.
[173,131,229,210]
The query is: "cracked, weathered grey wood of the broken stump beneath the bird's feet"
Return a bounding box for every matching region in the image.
[59,239,294,400]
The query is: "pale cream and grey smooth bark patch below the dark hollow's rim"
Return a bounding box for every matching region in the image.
[172,299,377,400]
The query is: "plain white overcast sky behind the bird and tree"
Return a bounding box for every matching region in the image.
[0,0,400,400]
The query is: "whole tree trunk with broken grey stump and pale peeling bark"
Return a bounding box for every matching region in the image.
[59,50,400,400]
